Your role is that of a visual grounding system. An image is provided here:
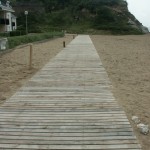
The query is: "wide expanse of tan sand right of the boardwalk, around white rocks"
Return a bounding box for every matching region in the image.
[91,34,150,150]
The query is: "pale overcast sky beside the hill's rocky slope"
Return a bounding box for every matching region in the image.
[127,0,150,28]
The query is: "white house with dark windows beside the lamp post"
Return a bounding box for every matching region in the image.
[0,1,17,32]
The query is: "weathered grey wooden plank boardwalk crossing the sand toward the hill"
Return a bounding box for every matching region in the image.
[0,36,141,150]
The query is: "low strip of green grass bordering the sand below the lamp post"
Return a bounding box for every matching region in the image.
[8,32,64,49]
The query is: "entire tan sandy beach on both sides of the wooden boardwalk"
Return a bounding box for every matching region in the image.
[0,34,150,150]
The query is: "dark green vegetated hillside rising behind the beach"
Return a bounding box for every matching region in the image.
[7,0,149,34]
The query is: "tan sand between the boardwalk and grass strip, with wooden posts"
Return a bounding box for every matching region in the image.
[0,35,73,103]
